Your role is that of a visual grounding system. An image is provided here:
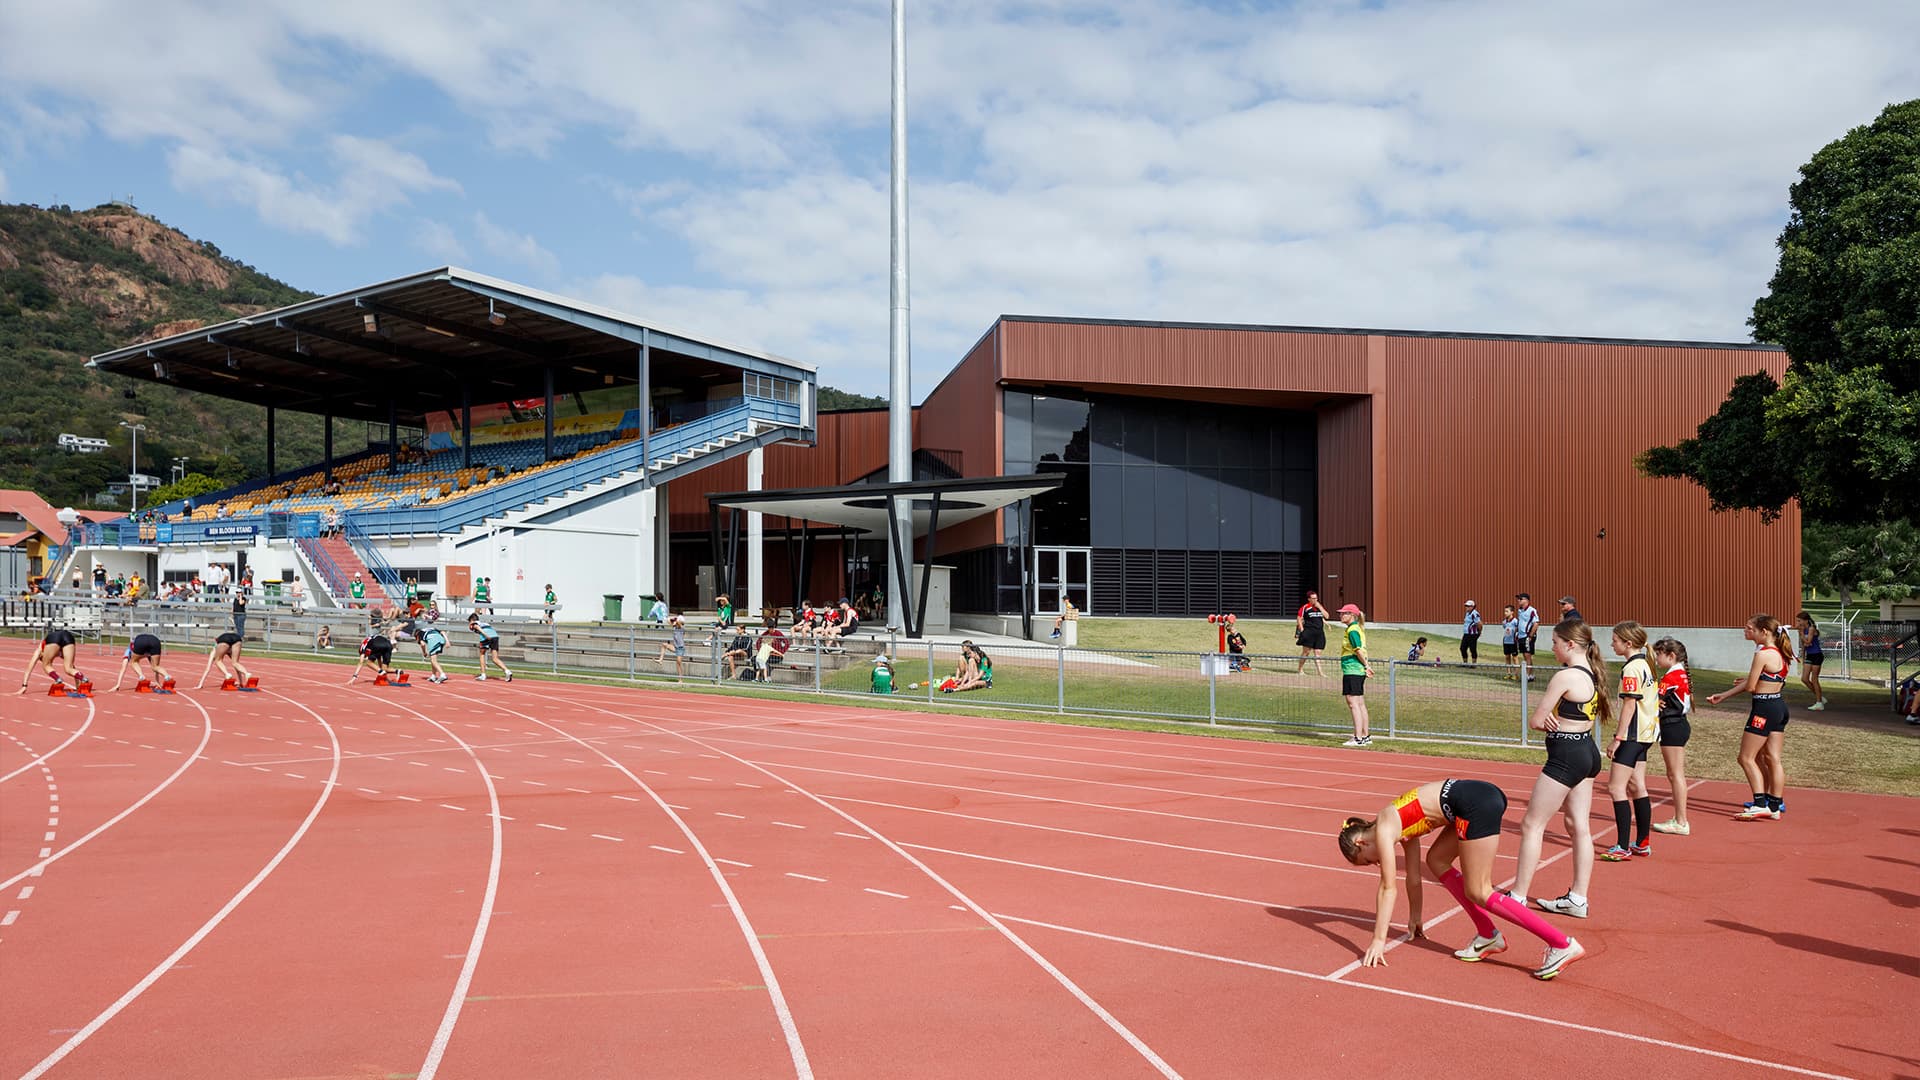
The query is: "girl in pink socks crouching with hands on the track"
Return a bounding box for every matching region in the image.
[1340,780,1586,978]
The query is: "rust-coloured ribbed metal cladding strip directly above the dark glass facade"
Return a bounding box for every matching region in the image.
[998,315,1367,402]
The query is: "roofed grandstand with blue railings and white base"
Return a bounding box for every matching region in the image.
[56,267,816,613]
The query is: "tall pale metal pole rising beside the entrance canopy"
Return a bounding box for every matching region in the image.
[881,0,914,626]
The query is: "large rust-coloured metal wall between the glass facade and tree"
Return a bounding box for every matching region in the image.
[1382,334,1801,626]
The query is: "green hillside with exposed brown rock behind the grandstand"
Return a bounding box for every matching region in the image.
[0,204,885,509]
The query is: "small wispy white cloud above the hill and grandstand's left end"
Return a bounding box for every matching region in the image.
[167,135,459,244]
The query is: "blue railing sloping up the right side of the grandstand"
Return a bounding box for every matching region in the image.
[348,398,801,536]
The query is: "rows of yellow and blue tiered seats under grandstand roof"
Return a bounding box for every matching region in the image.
[190,430,639,521]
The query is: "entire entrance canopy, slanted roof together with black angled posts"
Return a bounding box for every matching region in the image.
[707,473,1066,638]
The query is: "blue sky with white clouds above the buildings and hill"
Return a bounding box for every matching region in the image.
[0,0,1920,398]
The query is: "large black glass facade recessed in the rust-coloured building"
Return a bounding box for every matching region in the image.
[956,390,1315,615]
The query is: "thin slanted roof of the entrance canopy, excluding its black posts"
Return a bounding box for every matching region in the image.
[707,473,1066,538]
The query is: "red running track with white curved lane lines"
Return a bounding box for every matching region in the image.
[0,642,1920,1080]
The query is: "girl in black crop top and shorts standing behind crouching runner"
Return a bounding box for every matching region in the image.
[1507,619,1613,919]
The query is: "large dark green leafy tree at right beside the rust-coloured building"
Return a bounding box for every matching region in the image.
[1642,100,1920,523]
